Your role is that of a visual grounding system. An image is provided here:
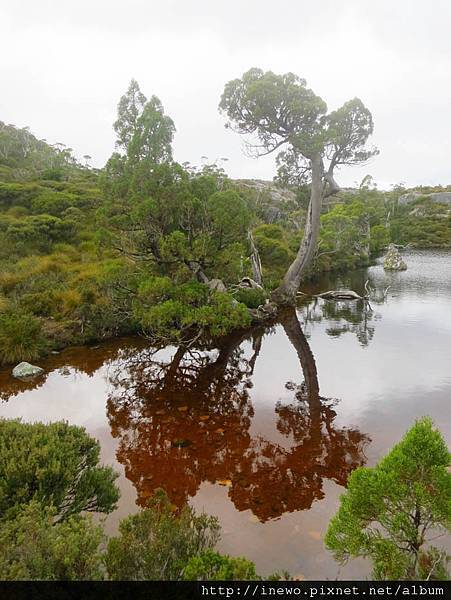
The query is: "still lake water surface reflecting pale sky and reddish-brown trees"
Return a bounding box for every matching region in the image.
[0,251,451,579]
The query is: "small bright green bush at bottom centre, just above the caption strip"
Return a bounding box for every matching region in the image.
[183,550,259,581]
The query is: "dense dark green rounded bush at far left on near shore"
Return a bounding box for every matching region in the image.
[0,419,119,520]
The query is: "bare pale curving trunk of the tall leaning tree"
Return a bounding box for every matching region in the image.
[271,155,323,306]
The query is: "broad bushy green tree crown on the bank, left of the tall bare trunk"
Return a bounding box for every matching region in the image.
[103,161,251,281]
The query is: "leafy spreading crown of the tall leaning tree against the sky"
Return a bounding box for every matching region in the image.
[219,68,377,186]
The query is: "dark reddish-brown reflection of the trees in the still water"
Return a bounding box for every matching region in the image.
[107,311,369,521]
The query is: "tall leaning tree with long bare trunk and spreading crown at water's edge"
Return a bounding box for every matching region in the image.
[219,68,378,305]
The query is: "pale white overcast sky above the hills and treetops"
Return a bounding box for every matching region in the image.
[0,0,451,188]
